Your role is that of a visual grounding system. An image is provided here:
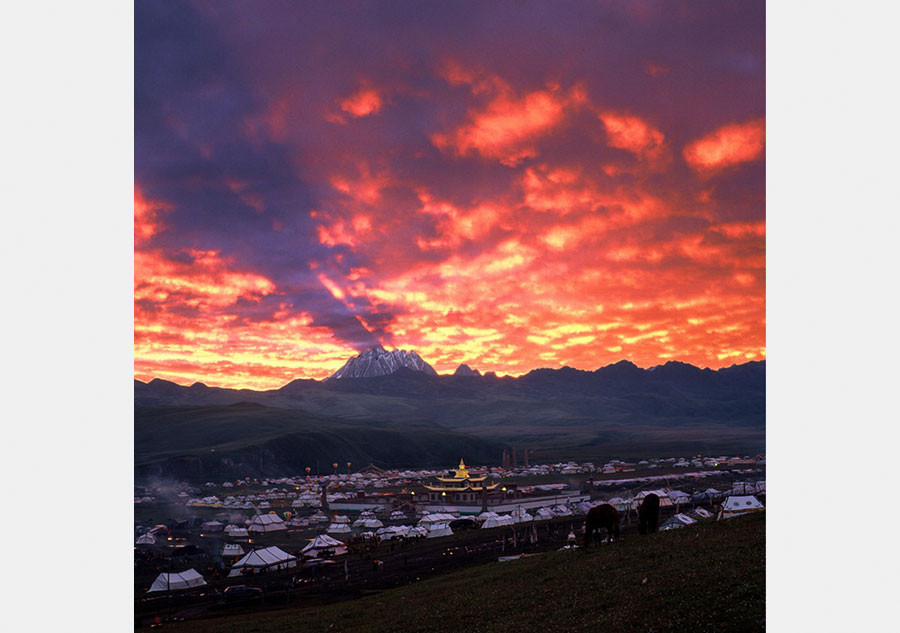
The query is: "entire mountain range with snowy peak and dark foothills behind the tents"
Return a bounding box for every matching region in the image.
[134,348,766,477]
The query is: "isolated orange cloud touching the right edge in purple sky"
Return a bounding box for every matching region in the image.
[684,119,766,173]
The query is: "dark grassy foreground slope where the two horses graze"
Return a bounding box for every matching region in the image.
[167,513,765,633]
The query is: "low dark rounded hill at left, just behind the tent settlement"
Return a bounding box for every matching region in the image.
[134,403,503,479]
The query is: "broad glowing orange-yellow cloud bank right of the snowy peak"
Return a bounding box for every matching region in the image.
[340,198,765,375]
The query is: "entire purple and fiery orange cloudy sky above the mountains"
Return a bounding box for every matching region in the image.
[134,0,766,389]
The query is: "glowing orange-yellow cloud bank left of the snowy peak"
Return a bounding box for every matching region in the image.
[134,239,355,389]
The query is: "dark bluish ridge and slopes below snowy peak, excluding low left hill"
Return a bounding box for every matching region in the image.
[134,361,766,476]
